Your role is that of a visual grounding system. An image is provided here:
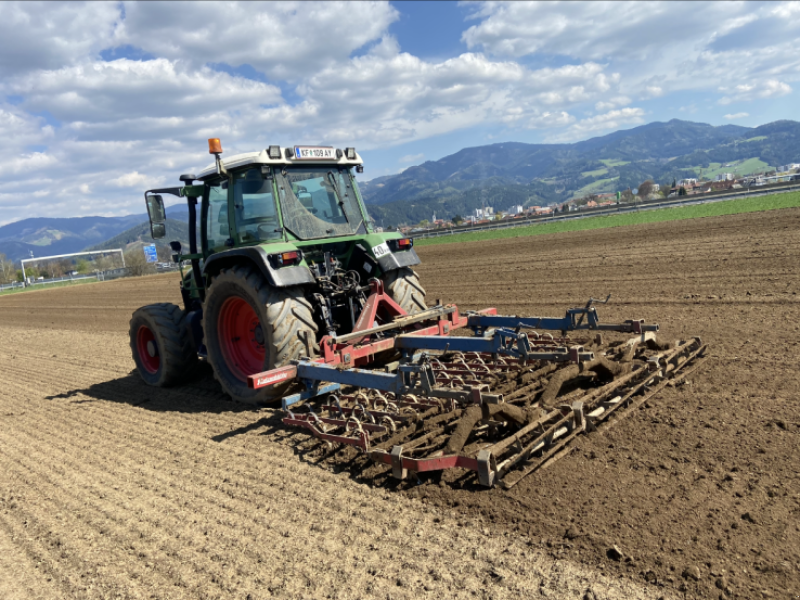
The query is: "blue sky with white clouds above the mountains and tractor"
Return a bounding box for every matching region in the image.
[0,1,800,224]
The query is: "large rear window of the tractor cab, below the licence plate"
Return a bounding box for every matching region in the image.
[275,167,366,240]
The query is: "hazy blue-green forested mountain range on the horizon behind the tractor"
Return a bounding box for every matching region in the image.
[0,119,800,260]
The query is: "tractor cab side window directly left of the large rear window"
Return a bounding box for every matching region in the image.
[233,168,282,245]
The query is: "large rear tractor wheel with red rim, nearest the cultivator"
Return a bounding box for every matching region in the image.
[203,266,317,404]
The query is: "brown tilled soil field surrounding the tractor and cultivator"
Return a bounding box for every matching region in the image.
[0,209,800,600]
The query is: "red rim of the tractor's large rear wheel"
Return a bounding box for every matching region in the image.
[217,297,266,381]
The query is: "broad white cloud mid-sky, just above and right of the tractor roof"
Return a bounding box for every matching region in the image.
[294,36,619,148]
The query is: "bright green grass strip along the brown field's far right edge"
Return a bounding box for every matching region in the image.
[414,192,800,246]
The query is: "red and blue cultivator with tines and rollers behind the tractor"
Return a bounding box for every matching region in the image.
[248,282,706,487]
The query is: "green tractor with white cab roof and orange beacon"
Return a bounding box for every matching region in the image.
[130,139,426,404]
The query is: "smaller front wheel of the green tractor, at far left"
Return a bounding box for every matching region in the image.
[130,302,197,387]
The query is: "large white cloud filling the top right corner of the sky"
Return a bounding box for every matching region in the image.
[462,1,800,98]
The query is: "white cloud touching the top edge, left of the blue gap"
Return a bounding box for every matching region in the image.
[117,1,399,81]
